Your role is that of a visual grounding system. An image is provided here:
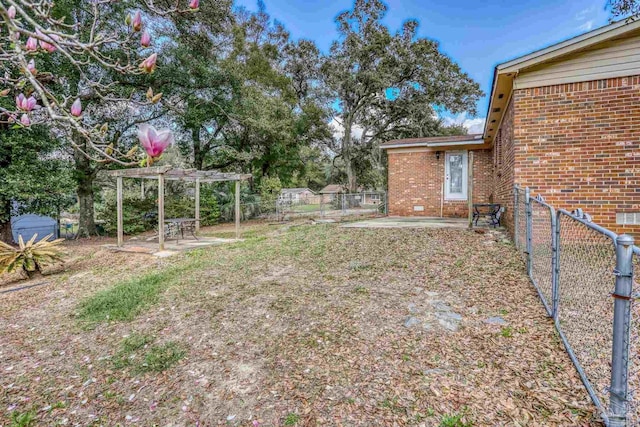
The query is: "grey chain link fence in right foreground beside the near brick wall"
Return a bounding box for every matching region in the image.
[514,187,640,427]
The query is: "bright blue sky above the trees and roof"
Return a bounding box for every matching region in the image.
[236,0,609,131]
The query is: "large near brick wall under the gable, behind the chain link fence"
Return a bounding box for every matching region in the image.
[497,76,640,235]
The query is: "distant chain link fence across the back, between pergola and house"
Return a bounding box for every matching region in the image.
[275,192,387,220]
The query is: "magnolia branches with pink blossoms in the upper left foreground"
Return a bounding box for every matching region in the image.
[0,0,199,165]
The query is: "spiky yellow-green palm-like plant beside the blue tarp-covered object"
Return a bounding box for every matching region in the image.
[0,233,64,277]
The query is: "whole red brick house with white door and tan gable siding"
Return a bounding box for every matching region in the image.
[382,21,640,234]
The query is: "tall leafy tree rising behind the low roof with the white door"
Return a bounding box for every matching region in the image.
[322,0,482,191]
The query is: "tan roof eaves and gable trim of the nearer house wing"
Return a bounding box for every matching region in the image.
[483,20,640,143]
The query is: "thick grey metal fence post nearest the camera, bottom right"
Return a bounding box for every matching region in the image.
[609,234,634,427]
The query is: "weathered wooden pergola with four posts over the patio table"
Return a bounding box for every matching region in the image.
[109,166,251,251]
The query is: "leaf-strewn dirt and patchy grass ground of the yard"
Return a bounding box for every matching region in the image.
[0,223,599,427]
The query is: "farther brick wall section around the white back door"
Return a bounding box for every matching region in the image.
[387,150,493,218]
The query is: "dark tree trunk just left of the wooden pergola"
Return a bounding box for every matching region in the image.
[74,151,98,237]
